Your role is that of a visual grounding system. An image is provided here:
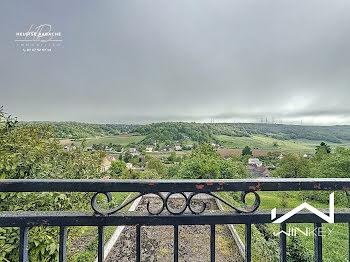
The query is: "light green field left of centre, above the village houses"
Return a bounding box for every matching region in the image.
[61,135,145,146]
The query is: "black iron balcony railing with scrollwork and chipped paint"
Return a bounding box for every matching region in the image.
[0,179,350,261]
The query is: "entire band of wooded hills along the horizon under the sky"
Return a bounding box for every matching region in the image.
[20,122,350,143]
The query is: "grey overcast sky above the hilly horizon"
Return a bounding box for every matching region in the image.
[0,0,350,124]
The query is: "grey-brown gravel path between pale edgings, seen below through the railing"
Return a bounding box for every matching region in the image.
[106,198,243,262]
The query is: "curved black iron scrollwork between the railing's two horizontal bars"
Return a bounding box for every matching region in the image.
[91,191,260,216]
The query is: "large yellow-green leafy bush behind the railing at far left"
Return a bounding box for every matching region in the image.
[0,109,104,261]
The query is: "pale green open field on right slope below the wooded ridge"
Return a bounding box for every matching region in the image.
[216,135,350,154]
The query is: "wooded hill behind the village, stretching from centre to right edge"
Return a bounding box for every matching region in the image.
[136,122,350,143]
